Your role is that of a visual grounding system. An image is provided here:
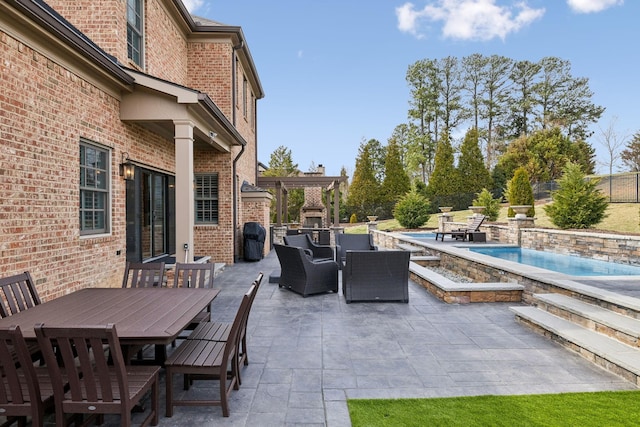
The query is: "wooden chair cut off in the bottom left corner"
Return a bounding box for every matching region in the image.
[0,325,55,427]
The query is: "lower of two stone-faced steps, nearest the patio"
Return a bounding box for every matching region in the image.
[510,306,640,385]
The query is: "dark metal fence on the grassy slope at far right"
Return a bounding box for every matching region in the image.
[533,172,640,203]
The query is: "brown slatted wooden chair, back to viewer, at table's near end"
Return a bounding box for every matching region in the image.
[35,324,160,427]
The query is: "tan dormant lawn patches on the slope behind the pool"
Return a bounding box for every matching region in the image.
[343,203,640,234]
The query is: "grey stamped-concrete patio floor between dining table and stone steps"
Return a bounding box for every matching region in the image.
[48,251,636,427]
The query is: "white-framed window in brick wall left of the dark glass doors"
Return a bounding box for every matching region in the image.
[80,140,111,235]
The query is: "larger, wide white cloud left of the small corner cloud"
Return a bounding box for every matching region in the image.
[396,0,544,40]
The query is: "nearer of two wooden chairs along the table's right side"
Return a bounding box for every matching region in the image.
[165,284,257,417]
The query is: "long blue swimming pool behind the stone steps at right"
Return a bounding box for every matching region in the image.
[468,247,640,276]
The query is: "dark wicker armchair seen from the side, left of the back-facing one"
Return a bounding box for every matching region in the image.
[273,244,338,297]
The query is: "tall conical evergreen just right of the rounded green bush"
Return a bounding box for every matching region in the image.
[427,132,460,210]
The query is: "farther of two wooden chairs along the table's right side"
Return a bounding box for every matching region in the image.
[187,272,264,385]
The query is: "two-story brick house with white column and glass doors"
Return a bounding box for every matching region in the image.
[0,0,270,300]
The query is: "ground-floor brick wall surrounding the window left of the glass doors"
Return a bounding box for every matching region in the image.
[0,28,174,301]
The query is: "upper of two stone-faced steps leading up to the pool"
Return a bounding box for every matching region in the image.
[534,293,640,347]
